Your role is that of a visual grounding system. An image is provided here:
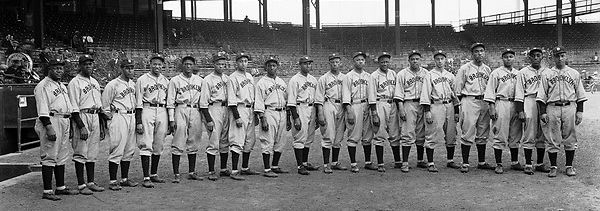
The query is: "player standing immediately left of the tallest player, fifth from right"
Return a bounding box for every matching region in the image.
[420,50,459,172]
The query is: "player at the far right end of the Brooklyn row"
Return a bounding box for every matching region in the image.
[536,46,587,177]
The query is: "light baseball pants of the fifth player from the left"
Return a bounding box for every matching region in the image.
[171,105,202,155]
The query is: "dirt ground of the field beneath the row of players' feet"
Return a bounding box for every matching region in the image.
[0,96,600,210]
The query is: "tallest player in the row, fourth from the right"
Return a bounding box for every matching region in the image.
[454,43,495,173]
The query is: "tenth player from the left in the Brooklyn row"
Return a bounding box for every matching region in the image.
[315,54,354,174]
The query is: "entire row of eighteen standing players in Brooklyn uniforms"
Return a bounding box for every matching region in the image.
[35,43,586,200]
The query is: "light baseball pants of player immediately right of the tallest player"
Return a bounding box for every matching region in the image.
[492,100,523,150]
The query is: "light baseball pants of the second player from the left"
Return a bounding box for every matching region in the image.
[71,113,100,163]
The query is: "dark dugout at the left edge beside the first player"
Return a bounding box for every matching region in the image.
[0,84,39,155]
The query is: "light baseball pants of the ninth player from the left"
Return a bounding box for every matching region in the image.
[292,103,317,149]
